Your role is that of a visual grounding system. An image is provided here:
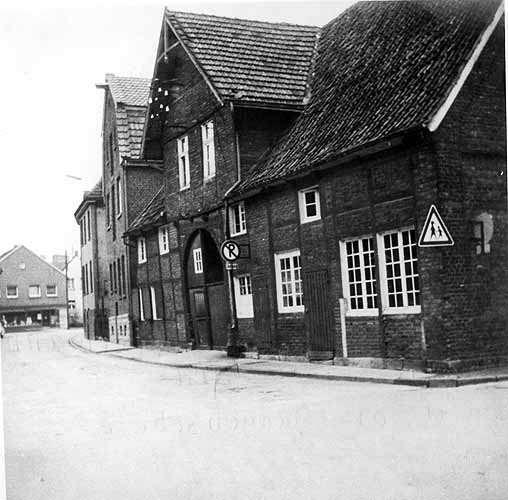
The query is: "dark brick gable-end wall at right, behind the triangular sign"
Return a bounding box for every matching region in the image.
[425,23,508,369]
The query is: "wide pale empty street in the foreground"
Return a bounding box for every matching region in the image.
[2,330,508,500]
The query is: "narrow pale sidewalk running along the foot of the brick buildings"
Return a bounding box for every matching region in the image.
[69,335,508,388]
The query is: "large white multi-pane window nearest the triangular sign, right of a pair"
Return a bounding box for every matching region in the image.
[377,228,421,314]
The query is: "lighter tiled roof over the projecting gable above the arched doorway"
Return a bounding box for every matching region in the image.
[166,10,319,105]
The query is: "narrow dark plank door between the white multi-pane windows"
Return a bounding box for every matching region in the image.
[303,269,335,360]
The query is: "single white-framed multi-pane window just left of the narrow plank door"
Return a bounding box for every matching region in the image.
[275,250,304,313]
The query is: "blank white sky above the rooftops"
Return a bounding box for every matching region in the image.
[0,1,354,257]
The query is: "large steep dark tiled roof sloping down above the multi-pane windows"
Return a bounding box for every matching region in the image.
[235,0,500,193]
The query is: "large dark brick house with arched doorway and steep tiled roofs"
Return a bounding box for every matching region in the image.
[124,0,508,370]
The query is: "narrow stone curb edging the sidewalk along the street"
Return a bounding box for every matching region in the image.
[68,339,508,389]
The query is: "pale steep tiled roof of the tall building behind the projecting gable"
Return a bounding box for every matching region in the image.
[106,74,151,158]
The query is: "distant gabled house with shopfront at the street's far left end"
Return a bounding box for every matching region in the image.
[0,245,67,328]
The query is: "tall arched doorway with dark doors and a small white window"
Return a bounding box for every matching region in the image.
[185,229,229,349]
